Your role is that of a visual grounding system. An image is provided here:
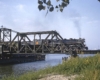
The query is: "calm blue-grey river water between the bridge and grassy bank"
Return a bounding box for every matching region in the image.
[0,54,93,77]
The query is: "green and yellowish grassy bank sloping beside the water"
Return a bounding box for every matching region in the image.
[2,54,100,80]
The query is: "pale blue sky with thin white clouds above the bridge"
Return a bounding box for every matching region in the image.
[0,0,100,49]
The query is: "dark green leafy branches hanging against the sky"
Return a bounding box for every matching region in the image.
[38,0,100,13]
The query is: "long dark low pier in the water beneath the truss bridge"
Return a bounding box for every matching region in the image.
[0,53,45,65]
